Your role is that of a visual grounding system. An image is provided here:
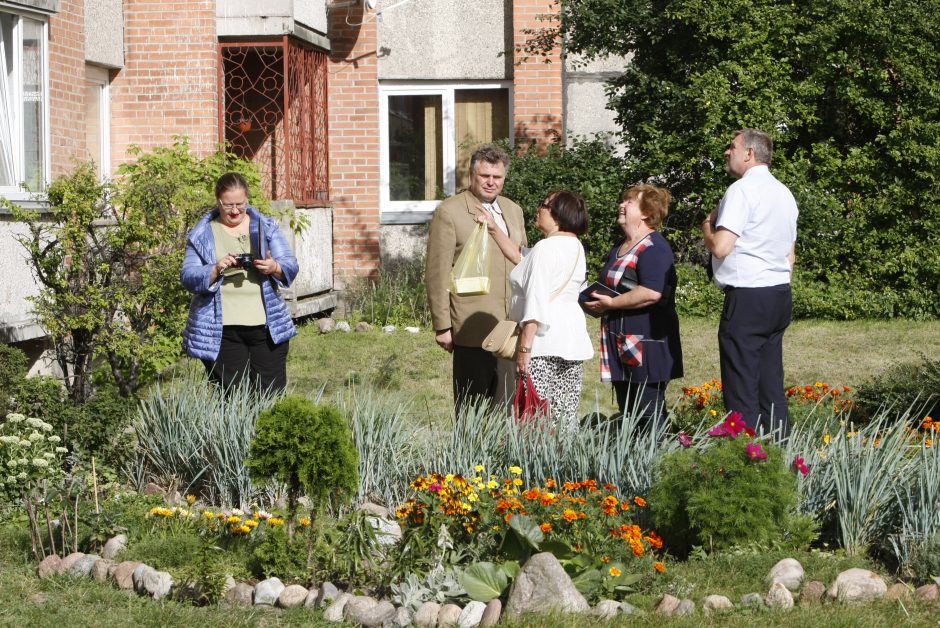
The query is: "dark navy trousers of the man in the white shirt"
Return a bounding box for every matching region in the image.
[718,284,793,439]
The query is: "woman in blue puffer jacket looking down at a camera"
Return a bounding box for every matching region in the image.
[180,172,298,390]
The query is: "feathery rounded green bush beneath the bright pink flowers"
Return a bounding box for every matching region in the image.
[650,435,798,555]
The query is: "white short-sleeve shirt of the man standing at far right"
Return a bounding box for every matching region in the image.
[712,166,799,288]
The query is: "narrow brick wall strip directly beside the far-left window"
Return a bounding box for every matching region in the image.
[49,0,89,178]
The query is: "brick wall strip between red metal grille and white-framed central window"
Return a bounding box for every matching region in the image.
[328,2,379,288]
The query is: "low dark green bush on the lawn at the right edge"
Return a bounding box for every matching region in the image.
[853,355,940,422]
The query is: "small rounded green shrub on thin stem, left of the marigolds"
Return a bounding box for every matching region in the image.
[245,396,359,539]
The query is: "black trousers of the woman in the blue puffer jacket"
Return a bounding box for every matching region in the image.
[202,325,290,391]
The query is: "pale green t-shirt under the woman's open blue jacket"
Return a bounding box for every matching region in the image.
[212,220,267,325]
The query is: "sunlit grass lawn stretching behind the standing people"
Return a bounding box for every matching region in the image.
[288,318,940,419]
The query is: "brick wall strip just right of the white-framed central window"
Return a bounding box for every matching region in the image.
[512,0,564,145]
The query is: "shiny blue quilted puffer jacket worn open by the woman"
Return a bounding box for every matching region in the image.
[180,207,298,360]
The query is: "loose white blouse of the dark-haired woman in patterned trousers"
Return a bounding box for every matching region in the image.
[509,236,594,361]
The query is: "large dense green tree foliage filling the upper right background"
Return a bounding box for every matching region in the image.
[541,0,940,318]
